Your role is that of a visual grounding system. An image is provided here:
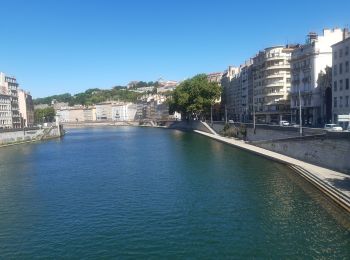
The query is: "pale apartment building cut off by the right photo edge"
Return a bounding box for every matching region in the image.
[332,33,350,128]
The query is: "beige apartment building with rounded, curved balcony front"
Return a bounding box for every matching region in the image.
[252,45,295,123]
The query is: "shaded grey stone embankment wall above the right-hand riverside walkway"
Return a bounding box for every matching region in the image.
[213,123,350,174]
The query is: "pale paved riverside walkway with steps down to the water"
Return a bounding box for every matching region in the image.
[194,130,350,212]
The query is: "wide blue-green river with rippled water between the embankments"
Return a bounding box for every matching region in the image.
[0,127,350,259]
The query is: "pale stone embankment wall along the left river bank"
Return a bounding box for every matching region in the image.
[0,126,63,146]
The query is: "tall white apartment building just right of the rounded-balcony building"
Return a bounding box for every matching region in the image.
[291,29,345,126]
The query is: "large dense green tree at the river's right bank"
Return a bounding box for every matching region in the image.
[169,74,221,118]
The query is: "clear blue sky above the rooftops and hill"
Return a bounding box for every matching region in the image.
[0,0,350,97]
